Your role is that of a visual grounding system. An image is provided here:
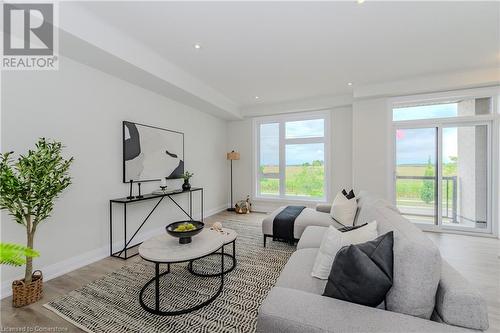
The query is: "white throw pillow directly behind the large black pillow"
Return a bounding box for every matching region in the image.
[311,221,378,280]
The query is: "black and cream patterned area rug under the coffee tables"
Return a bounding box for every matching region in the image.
[44,220,295,333]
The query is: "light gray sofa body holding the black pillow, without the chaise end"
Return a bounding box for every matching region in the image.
[257,192,488,333]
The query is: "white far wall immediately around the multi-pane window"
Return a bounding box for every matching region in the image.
[227,107,352,212]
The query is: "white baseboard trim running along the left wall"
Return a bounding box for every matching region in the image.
[0,205,227,299]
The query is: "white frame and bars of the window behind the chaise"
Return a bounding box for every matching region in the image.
[252,110,331,203]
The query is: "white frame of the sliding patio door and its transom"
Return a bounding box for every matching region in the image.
[388,88,500,235]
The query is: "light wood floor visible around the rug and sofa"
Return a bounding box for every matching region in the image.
[0,212,500,333]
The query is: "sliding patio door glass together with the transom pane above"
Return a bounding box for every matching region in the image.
[392,93,494,232]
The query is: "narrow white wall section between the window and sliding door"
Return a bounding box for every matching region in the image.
[352,98,392,199]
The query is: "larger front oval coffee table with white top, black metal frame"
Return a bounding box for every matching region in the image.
[139,228,226,316]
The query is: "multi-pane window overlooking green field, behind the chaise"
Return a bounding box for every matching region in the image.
[254,112,329,201]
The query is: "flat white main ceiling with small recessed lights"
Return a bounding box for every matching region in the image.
[80,0,500,107]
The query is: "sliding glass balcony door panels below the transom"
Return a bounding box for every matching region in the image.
[394,122,491,232]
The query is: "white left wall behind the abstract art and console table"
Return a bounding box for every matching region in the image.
[1,58,228,291]
